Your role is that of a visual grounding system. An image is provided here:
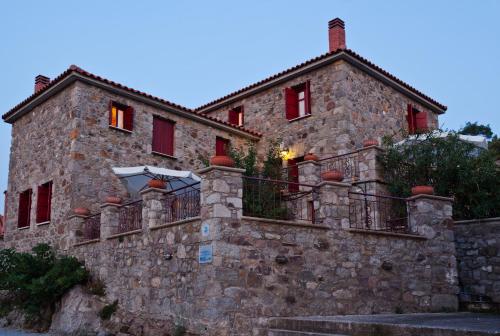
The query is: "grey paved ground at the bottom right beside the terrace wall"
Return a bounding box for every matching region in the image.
[292,313,500,333]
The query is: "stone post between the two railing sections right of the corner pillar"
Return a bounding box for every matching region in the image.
[316,181,351,229]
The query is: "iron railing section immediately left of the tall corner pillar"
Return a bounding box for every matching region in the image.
[165,183,201,223]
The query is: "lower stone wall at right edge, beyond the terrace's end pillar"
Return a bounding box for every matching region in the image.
[454,218,500,305]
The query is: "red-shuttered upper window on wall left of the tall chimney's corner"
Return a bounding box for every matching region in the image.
[285,81,311,120]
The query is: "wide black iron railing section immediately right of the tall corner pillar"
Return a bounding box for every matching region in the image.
[243,176,316,223]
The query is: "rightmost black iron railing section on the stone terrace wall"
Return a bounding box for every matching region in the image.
[349,192,414,233]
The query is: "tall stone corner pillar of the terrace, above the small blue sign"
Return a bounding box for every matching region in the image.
[198,166,245,240]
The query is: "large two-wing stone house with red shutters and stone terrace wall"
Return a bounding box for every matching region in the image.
[3,19,456,335]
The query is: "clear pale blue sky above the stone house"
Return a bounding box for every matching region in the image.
[0,0,500,213]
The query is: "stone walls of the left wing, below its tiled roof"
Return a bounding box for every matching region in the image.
[5,81,254,249]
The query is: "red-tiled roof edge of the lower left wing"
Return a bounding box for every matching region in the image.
[2,65,262,137]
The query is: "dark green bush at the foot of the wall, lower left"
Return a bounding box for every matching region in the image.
[0,244,88,318]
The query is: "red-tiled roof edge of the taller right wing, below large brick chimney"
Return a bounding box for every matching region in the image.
[195,49,447,111]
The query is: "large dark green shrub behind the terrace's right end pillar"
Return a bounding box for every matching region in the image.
[380,132,500,219]
